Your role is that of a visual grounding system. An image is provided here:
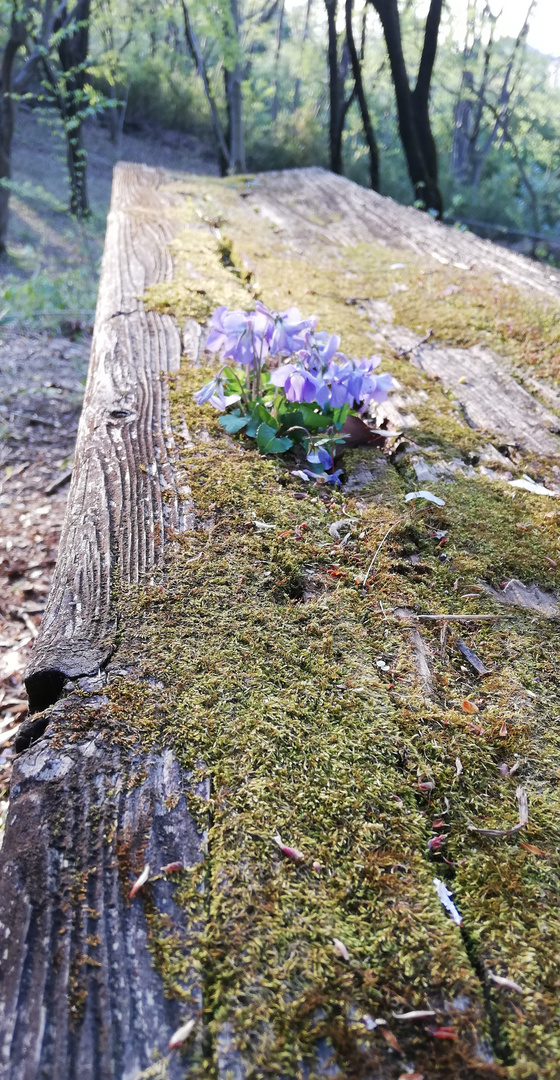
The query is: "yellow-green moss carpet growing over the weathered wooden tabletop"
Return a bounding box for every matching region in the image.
[101,172,560,1080]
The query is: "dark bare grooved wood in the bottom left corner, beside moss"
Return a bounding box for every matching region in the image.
[0,694,205,1080]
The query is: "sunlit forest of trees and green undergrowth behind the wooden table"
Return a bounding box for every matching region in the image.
[0,0,560,328]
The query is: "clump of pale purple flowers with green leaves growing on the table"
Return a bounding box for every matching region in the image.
[194,301,393,483]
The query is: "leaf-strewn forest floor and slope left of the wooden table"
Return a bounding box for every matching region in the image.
[0,109,218,821]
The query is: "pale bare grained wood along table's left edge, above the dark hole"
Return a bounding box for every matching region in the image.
[26,164,194,711]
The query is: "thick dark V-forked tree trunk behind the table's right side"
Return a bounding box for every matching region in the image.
[370,0,443,217]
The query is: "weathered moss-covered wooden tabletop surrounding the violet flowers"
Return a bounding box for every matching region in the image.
[0,164,560,1080]
